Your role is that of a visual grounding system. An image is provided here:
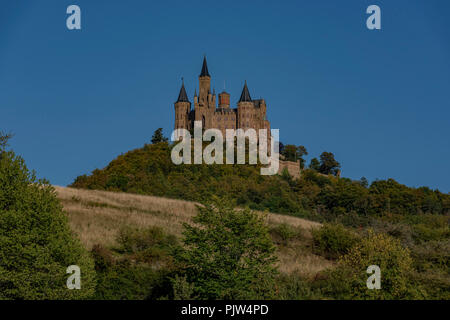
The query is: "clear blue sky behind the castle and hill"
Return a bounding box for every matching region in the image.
[0,0,450,192]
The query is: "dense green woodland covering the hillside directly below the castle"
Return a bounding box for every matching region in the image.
[72,143,450,228]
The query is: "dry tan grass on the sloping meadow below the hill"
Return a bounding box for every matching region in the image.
[55,186,330,275]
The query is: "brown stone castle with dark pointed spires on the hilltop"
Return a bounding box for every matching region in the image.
[175,57,270,136]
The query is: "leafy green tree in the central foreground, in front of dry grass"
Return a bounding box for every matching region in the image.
[178,199,277,299]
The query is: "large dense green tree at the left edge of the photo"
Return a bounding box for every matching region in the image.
[0,141,95,300]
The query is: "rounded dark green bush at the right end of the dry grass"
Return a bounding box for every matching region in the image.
[312,223,358,259]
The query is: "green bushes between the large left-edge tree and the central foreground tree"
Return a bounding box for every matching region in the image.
[92,227,177,300]
